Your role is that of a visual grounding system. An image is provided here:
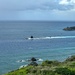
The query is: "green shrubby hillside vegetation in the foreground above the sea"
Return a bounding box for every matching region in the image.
[5,56,75,75]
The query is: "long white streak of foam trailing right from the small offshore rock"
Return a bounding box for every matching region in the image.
[28,36,75,40]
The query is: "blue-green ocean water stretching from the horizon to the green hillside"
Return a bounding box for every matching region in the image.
[0,21,75,75]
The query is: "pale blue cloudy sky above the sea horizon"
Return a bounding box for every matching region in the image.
[0,0,75,21]
